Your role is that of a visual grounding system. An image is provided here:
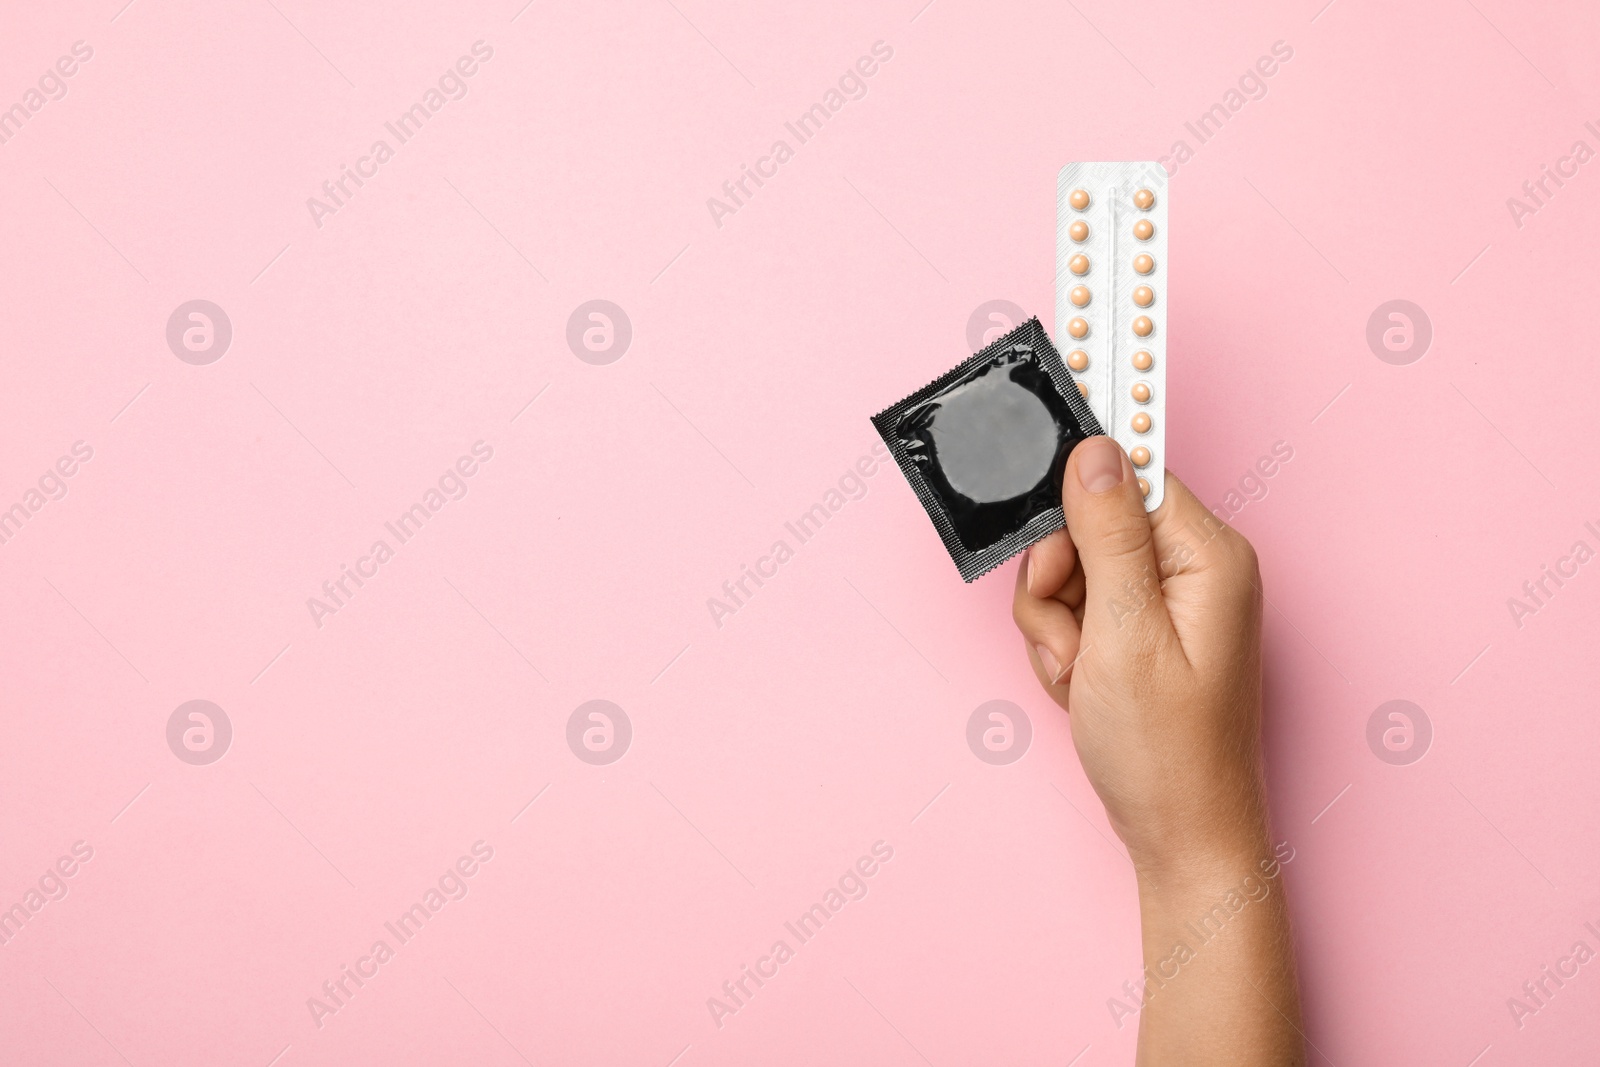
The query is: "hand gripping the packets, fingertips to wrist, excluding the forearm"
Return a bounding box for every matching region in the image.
[1013,437,1270,880]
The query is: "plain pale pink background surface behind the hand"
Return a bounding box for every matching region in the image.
[0,0,1600,1067]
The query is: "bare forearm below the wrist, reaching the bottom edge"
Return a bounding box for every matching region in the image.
[1138,833,1306,1067]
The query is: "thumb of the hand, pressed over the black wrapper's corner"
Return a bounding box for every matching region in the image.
[1061,437,1171,648]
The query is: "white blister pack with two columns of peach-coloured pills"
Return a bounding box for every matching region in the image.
[1056,163,1168,512]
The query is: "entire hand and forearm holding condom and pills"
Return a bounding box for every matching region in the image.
[1013,437,1306,1067]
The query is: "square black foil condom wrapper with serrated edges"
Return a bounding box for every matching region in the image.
[872,318,1104,582]
